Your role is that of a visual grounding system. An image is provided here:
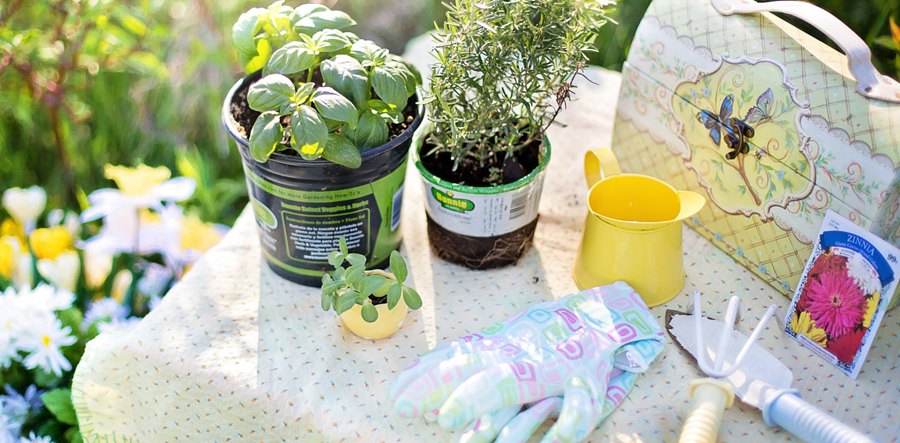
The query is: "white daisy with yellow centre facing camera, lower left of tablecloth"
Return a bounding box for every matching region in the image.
[18,317,78,376]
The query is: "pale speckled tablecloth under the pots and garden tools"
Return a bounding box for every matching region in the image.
[73,40,900,442]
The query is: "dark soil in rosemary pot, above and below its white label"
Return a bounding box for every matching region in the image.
[419,139,541,269]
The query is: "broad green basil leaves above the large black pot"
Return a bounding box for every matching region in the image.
[232,1,421,168]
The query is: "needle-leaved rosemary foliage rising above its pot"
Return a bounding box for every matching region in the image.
[425,0,611,185]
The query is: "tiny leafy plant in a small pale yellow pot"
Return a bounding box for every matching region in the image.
[322,237,422,340]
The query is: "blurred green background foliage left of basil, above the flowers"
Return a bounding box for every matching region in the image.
[0,0,246,224]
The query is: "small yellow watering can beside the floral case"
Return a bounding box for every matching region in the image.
[574,149,706,307]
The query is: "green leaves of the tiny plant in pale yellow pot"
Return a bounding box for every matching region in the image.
[322,237,422,323]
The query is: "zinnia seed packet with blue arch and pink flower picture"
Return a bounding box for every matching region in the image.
[785,211,900,378]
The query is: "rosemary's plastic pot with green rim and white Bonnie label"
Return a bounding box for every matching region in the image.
[413,137,550,269]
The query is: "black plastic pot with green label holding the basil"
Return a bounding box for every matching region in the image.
[222,74,422,286]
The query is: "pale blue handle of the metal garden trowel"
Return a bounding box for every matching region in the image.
[763,390,874,443]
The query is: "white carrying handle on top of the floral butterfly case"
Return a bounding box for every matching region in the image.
[711,0,900,103]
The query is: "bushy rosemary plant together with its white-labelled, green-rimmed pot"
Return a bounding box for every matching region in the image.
[414,0,608,269]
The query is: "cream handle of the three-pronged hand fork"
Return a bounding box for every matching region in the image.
[678,378,734,443]
